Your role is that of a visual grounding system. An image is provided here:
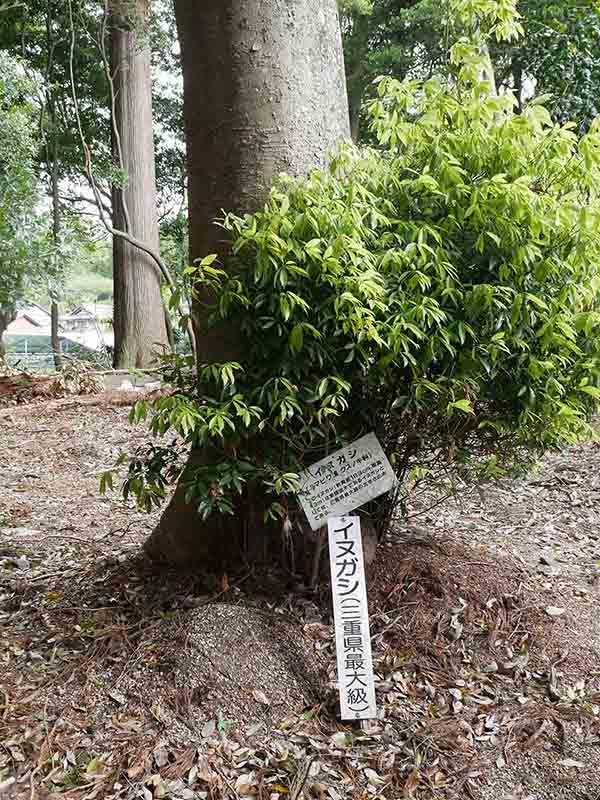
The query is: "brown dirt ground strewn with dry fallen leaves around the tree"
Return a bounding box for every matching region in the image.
[0,396,600,800]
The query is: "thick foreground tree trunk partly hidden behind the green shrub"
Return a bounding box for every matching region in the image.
[146,0,349,564]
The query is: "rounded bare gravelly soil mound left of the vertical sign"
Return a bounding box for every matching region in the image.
[87,603,326,745]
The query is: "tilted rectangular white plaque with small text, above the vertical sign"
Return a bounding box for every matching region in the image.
[298,433,396,531]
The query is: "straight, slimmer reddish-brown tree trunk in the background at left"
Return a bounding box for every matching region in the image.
[111,0,168,369]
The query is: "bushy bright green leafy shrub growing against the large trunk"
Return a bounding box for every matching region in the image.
[118,4,600,528]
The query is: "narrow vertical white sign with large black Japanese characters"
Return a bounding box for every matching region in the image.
[327,517,377,719]
